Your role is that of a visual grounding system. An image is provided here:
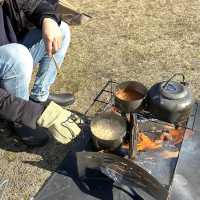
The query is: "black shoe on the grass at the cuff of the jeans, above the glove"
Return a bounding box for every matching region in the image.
[47,93,75,106]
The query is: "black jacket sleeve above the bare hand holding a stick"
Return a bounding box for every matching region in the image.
[18,0,61,28]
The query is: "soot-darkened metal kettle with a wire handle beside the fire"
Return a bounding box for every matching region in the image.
[147,73,193,125]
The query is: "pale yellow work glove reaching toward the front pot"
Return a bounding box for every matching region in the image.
[37,102,81,144]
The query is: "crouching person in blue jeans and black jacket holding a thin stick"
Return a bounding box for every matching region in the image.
[0,0,74,141]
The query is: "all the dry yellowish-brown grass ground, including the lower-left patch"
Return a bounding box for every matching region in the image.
[0,0,200,200]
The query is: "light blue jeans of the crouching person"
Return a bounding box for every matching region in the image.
[0,22,70,102]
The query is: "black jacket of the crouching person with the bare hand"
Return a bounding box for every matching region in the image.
[3,0,61,39]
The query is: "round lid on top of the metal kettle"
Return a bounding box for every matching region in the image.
[161,81,188,100]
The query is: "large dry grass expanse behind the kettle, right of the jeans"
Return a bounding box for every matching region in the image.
[52,0,200,110]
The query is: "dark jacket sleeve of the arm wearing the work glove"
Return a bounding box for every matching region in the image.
[0,88,44,128]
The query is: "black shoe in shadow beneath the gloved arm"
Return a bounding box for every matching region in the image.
[12,124,49,147]
